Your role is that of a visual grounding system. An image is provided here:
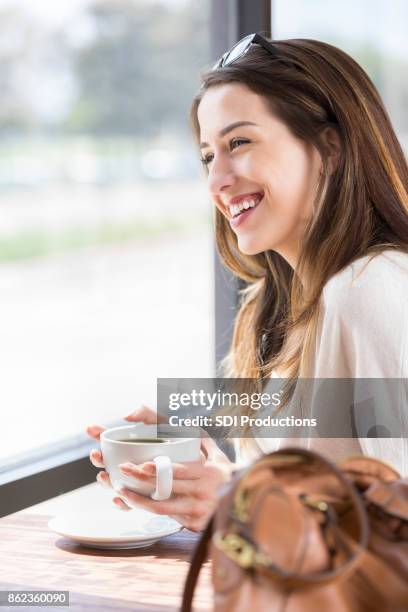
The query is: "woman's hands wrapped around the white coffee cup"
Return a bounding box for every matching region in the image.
[87,406,233,531]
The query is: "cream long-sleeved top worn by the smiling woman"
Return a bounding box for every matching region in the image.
[241,250,408,476]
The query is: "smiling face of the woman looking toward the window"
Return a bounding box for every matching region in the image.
[198,83,322,267]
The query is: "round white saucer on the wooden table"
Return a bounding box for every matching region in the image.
[48,508,183,549]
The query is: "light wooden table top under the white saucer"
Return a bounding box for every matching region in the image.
[0,485,212,612]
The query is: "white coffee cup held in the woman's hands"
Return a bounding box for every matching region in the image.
[100,423,200,501]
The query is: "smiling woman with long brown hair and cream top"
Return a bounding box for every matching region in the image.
[88,35,408,530]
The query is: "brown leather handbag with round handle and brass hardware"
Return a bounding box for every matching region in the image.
[182,448,408,612]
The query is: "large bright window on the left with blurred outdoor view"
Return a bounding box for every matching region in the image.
[0,0,213,467]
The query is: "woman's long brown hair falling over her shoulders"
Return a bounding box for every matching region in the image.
[191,39,408,392]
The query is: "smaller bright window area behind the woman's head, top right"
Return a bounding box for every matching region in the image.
[272,0,408,150]
